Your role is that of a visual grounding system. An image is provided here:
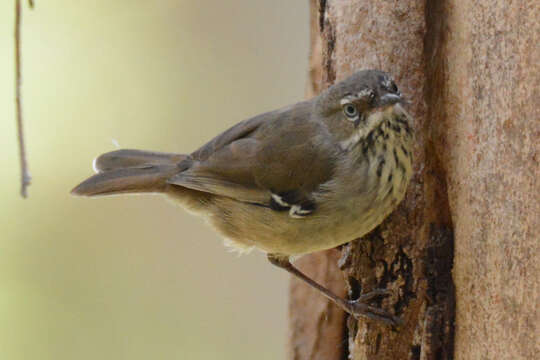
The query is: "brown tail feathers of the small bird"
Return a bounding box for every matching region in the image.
[71,149,188,196]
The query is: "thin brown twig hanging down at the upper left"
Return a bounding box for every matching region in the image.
[15,0,34,198]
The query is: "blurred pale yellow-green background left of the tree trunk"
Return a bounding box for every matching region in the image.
[0,0,309,360]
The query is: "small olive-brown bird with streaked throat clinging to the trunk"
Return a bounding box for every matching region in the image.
[72,70,414,324]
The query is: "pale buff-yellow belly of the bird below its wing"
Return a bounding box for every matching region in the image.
[208,166,408,255]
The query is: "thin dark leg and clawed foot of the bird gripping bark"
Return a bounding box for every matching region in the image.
[268,254,401,325]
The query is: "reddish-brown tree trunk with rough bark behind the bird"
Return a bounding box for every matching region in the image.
[289,0,540,360]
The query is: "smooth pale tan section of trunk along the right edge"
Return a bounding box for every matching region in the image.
[427,0,540,359]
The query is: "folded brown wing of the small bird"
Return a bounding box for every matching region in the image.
[168,105,336,205]
